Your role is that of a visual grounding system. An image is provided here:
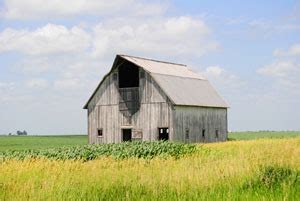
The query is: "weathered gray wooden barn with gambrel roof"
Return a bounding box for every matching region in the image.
[84,55,228,144]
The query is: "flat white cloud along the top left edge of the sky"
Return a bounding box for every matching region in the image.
[3,0,166,20]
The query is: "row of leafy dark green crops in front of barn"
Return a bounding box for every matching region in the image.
[0,141,196,161]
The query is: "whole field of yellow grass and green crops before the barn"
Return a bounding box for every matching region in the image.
[0,132,300,200]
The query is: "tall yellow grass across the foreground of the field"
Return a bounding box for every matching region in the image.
[0,138,300,200]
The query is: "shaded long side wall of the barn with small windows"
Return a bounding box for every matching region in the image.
[173,106,228,142]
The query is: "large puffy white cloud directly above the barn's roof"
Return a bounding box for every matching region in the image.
[93,16,218,57]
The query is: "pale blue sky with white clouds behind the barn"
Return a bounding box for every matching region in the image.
[0,0,300,134]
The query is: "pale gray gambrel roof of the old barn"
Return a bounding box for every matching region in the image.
[84,55,228,109]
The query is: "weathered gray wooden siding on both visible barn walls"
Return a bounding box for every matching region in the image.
[88,66,227,143]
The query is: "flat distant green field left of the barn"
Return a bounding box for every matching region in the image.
[0,135,88,151]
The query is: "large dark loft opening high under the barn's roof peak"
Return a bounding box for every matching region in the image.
[119,62,139,88]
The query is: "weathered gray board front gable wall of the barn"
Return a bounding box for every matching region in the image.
[88,69,173,143]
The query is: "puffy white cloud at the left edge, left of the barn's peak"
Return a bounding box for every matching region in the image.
[0,24,90,55]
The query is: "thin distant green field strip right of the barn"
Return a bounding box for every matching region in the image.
[228,131,300,140]
